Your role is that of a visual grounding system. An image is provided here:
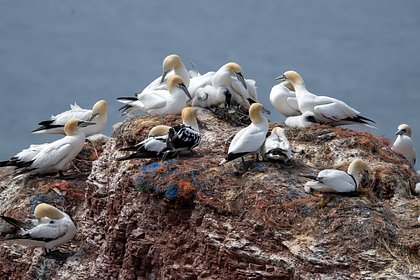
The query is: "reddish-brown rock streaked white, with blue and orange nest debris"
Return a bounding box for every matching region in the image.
[0,110,420,279]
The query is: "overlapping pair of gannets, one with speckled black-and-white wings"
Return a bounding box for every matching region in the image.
[117,107,201,160]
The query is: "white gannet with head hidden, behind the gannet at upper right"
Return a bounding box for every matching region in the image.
[270,81,301,117]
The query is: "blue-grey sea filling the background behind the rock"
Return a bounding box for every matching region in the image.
[0,0,420,168]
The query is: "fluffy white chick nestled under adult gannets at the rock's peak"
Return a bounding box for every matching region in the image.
[191,85,232,108]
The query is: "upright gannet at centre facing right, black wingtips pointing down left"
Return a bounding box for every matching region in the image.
[219,103,270,165]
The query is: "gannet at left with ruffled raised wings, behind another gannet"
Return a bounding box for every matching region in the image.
[32,100,108,137]
